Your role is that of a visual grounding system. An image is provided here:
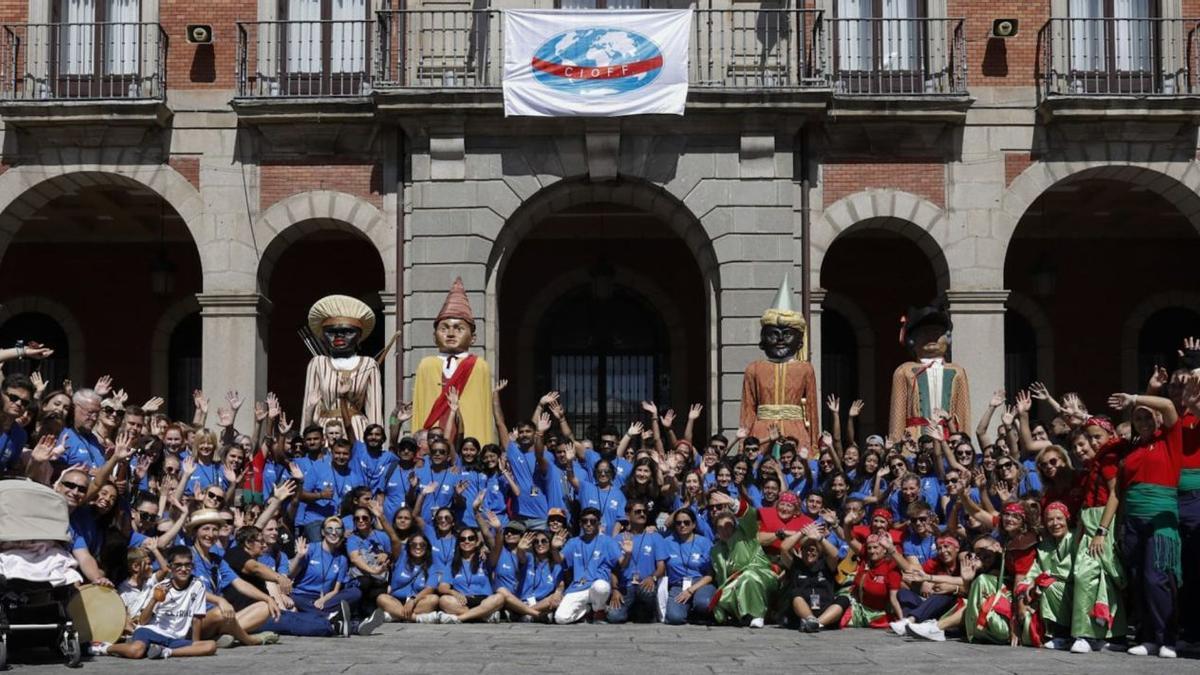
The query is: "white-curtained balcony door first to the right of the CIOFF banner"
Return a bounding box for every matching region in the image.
[834,0,929,94]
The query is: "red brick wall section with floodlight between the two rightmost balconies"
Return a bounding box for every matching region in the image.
[947,0,1050,86]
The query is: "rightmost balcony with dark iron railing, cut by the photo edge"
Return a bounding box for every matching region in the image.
[1038,18,1200,120]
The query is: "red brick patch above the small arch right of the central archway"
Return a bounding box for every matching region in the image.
[821,160,946,208]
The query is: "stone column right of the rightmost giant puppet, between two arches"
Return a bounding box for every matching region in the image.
[947,288,1008,430]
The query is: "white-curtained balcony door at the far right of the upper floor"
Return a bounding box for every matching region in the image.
[1067,0,1162,94]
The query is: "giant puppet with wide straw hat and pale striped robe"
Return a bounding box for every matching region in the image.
[301,295,383,440]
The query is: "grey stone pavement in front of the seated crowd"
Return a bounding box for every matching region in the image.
[4,623,1200,675]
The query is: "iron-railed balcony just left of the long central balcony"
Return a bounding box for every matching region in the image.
[234,19,378,121]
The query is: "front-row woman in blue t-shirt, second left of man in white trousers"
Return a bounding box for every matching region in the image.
[438,527,504,623]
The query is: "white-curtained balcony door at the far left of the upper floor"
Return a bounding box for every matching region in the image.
[50,0,141,98]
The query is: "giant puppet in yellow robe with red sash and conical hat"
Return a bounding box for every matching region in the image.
[413,277,496,444]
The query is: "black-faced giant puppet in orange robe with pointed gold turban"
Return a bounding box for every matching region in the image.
[740,276,821,448]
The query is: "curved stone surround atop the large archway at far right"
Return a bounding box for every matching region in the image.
[992,162,1200,258]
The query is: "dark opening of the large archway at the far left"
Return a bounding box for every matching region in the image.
[0,172,202,398]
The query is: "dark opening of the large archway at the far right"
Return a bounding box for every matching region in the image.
[1004,174,1200,403]
